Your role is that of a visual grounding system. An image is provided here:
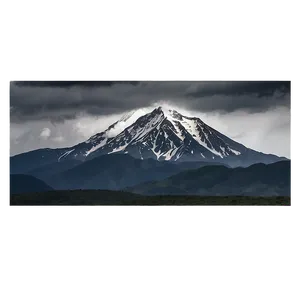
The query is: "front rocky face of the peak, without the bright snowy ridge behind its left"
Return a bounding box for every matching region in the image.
[81,107,283,166]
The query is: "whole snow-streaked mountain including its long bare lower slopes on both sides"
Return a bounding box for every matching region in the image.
[10,107,286,174]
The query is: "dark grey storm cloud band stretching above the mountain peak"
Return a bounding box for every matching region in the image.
[9,72,296,122]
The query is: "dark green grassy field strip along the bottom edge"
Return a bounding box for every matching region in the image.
[10,190,294,208]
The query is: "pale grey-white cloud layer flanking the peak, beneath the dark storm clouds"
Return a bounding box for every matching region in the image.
[9,106,296,157]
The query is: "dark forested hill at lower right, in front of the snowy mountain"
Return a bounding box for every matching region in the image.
[126,161,295,196]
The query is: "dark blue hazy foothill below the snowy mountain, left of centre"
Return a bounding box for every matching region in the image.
[37,154,225,190]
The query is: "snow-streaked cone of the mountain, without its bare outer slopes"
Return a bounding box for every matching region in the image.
[56,106,276,166]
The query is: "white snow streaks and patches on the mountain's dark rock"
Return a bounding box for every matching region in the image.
[78,108,241,160]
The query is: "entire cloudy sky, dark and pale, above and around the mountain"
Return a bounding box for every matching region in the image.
[0,72,296,158]
